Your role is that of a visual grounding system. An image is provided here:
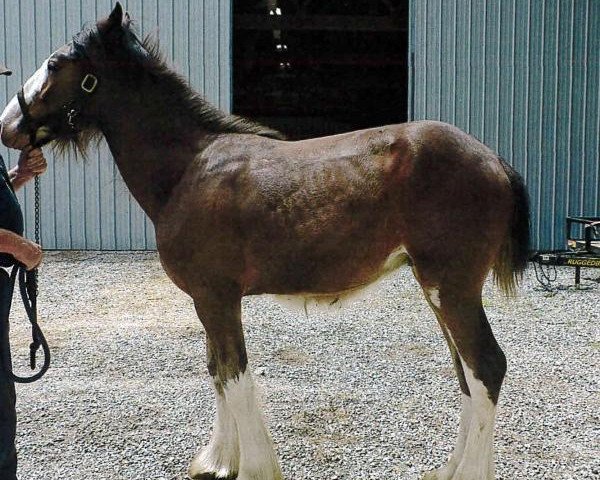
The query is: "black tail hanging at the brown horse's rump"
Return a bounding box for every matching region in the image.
[494,157,530,295]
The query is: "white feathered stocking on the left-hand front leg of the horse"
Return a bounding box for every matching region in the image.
[189,392,240,478]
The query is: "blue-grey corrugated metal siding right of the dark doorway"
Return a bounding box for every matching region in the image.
[409,0,600,248]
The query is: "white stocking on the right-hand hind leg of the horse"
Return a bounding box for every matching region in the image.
[452,359,496,480]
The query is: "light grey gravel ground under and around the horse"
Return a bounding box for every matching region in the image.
[5,252,600,480]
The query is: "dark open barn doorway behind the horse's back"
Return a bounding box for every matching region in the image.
[233,0,408,139]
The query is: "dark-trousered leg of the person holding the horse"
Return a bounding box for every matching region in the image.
[0,268,17,480]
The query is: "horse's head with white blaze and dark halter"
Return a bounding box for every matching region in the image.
[0,2,141,150]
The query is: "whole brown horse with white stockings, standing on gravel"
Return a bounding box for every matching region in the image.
[2,4,529,480]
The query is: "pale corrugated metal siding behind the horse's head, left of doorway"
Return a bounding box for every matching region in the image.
[0,0,231,250]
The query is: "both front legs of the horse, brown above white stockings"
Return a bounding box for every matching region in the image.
[189,289,283,480]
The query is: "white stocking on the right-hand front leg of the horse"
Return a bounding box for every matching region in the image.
[224,370,283,480]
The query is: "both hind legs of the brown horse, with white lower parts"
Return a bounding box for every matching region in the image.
[417,275,506,480]
